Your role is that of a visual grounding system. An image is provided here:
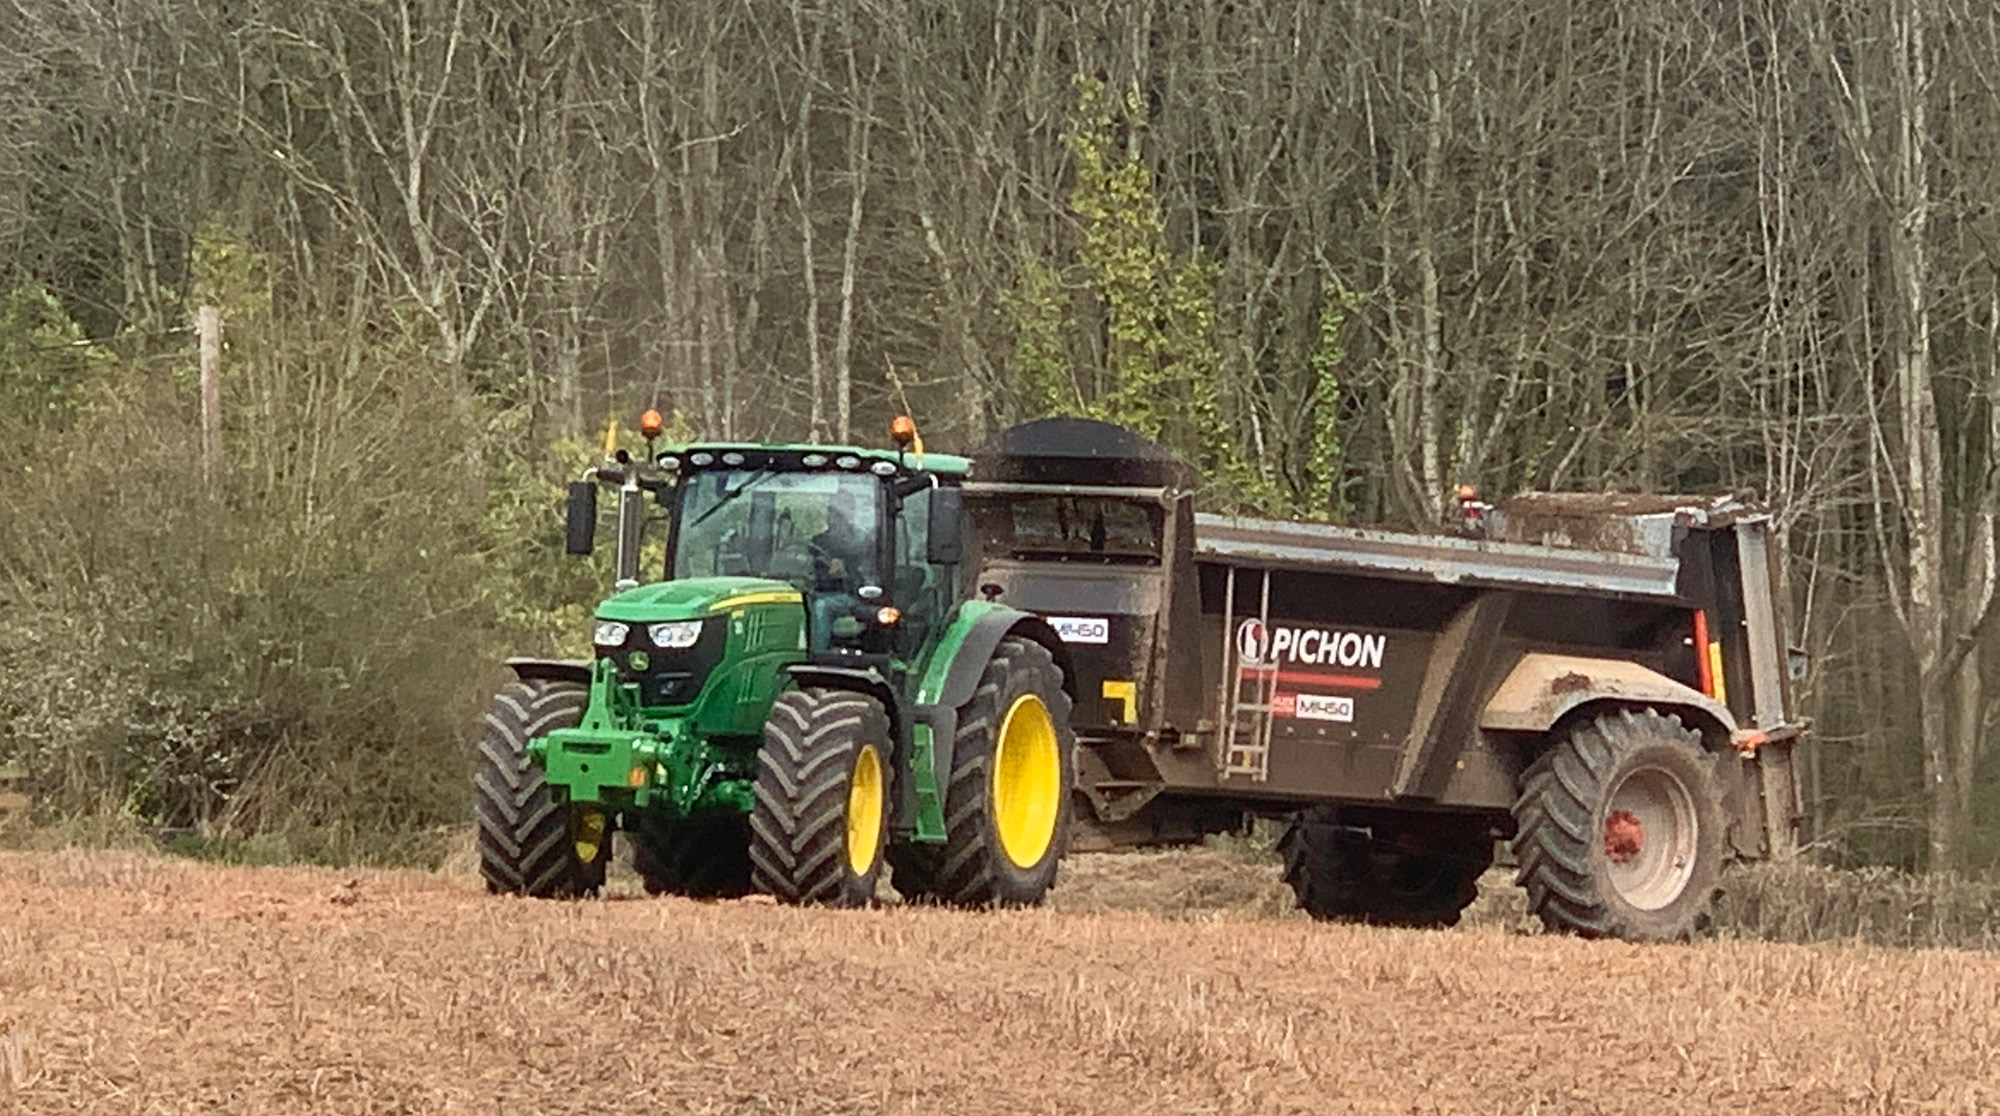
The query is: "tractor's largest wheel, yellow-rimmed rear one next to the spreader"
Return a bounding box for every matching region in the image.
[890,636,1076,906]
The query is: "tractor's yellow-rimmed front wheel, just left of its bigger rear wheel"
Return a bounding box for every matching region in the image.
[750,690,892,906]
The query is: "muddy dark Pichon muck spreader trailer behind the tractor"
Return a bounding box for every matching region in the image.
[964,418,1800,940]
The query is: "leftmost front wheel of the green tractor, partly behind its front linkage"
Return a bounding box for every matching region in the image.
[472,680,610,898]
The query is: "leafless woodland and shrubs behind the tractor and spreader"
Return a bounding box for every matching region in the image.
[0,0,2000,870]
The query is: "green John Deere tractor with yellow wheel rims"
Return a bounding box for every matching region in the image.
[472,412,1076,906]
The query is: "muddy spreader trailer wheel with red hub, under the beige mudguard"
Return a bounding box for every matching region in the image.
[1514,710,1724,942]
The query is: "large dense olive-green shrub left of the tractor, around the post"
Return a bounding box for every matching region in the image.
[0,286,596,860]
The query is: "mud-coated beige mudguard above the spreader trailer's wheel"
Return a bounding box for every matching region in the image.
[1480,652,1736,748]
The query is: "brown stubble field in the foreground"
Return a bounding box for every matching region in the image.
[0,852,2000,1116]
